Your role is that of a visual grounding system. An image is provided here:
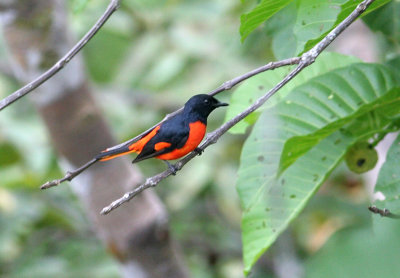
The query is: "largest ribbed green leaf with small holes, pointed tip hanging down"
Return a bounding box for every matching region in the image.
[237,64,397,273]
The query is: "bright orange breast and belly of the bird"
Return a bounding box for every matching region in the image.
[157,121,206,160]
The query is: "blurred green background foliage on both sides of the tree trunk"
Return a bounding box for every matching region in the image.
[0,0,400,278]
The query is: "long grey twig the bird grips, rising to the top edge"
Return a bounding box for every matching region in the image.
[101,0,374,214]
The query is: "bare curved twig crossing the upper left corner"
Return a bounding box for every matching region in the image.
[0,0,120,111]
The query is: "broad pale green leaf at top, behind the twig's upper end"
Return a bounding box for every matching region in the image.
[266,0,390,59]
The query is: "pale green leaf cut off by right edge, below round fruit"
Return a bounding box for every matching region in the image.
[375,135,400,214]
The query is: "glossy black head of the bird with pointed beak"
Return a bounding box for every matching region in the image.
[183,94,228,121]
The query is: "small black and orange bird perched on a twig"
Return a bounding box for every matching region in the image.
[95,94,228,174]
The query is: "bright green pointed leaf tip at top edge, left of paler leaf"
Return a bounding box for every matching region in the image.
[240,0,293,41]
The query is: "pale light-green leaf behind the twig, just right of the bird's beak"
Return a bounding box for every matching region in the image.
[226,52,360,133]
